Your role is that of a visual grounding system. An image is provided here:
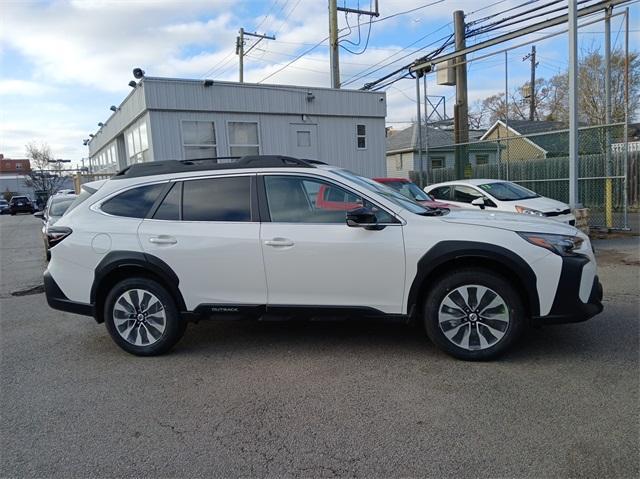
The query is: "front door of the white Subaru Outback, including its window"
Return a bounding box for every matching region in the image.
[259,174,405,314]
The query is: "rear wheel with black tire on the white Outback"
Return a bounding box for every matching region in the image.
[104,277,187,356]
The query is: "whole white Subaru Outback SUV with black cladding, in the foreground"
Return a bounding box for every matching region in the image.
[44,156,602,360]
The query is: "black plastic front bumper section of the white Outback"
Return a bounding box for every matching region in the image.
[533,255,604,324]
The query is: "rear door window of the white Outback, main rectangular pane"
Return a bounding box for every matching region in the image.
[182,176,251,221]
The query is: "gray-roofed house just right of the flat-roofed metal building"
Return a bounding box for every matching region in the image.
[386,123,499,178]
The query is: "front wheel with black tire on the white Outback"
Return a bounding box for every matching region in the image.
[424,268,526,361]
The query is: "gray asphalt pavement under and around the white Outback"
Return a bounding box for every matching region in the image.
[0,216,640,478]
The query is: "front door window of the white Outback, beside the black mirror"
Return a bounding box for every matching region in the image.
[264,175,396,224]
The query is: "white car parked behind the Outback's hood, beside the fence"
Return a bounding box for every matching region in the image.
[424,179,576,226]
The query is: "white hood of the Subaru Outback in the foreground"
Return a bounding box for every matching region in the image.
[442,209,578,235]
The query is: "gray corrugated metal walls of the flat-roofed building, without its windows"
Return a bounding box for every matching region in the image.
[89,78,386,176]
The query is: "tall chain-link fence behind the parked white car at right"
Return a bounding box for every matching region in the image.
[411,120,640,229]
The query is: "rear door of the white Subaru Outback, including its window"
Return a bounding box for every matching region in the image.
[138,175,267,310]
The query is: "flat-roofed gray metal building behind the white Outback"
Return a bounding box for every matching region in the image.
[88,77,386,177]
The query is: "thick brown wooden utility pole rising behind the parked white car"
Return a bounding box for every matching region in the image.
[453,10,469,178]
